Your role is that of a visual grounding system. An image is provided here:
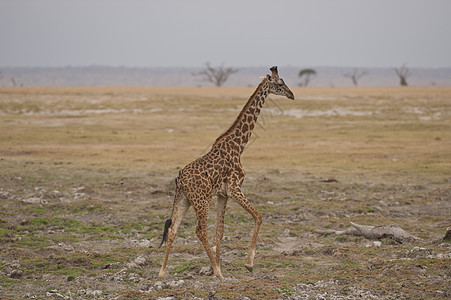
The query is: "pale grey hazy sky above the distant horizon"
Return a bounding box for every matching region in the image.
[0,0,451,67]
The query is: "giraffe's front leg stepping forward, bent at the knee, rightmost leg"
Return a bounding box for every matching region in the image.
[231,188,262,272]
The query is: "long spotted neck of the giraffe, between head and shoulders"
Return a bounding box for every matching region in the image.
[213,78,269,154]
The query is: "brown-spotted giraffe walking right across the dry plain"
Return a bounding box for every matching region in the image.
[159,66,294,280]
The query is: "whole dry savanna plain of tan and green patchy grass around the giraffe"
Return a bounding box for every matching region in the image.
[0,87,451,299]
